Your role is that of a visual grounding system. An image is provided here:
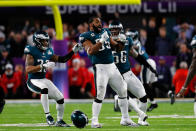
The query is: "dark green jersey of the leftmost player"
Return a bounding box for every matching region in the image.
[24,45,54,79]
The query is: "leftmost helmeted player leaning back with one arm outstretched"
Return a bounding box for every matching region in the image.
[24,31,81,127]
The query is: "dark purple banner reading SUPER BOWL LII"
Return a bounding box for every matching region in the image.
[46,1,178,14]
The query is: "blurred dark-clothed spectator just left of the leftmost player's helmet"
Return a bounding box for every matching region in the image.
[10,32,26,57]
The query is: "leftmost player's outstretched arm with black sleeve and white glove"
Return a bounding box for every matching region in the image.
[50,43,82,63]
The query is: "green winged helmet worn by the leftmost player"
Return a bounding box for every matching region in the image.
[33,31,50,51]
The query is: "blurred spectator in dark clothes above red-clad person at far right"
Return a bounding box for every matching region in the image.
[176,44,192,69]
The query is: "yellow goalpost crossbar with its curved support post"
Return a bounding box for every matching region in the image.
[0,0,141,40]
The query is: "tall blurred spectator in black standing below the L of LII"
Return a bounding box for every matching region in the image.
[145,17,158,55]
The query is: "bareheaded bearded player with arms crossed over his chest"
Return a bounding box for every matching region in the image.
[80,17,137,128]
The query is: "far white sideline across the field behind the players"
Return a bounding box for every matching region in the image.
[6,98,194,104]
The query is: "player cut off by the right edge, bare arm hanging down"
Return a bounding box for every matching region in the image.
[177,35,196,113]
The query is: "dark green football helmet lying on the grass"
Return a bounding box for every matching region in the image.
[71,110,88,128]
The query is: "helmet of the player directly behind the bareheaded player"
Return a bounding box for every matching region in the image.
[109,21,123,40]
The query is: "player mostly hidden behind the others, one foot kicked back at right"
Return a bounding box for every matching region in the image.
[126,31,175,111]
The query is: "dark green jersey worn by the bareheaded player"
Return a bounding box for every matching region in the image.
[79,28,114,64]
